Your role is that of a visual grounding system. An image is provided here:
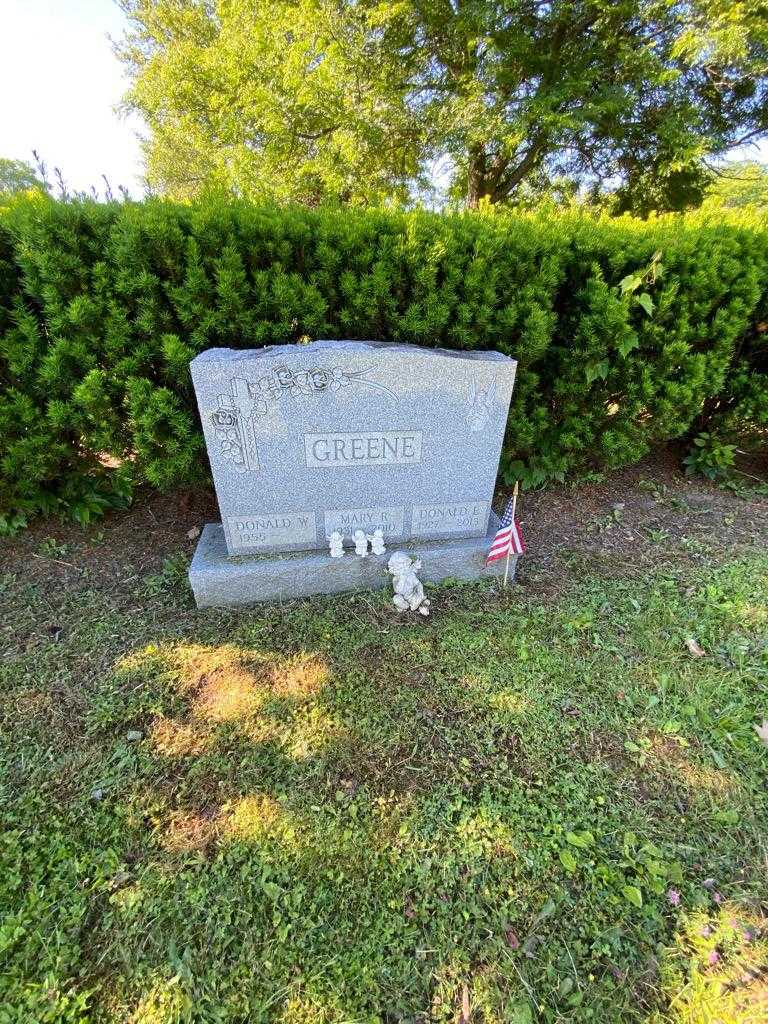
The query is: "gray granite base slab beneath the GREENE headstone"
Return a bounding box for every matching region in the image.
[189,513,517,608]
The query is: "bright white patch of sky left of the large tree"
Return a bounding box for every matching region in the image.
[0,0,143,196]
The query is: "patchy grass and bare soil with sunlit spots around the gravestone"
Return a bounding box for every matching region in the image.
[0,467,768,1024]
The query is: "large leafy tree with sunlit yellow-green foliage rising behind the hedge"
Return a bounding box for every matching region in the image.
[118,0,768,209]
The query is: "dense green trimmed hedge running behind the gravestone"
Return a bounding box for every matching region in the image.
[0,196,768,528]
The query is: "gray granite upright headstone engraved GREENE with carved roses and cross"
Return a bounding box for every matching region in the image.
[191,341,516,603]
